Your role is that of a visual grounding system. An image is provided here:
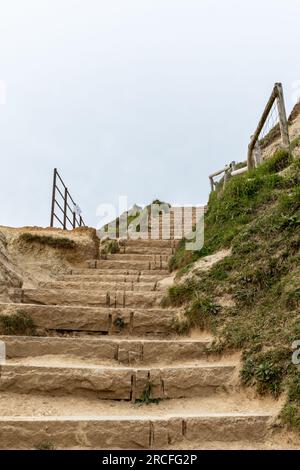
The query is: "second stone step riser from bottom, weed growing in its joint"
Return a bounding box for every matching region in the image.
[0,361,235,401]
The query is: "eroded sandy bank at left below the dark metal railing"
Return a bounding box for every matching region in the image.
[0,227,99,302]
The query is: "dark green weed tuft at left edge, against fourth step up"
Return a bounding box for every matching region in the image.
[0,310,36,336]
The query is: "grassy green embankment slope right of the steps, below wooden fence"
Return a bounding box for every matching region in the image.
[164,150,300,431]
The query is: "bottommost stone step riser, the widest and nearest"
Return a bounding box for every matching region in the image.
[0,412,273,450]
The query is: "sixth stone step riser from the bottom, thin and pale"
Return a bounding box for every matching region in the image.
[39,280,156,292]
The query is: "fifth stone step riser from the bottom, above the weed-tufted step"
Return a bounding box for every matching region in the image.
[21,288,163,308]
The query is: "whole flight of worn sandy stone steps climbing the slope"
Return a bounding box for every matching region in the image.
[0,240,277,449]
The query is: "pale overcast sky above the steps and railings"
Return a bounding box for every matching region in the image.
[0,0,300,226]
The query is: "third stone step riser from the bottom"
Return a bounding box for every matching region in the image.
[0,336,210,365]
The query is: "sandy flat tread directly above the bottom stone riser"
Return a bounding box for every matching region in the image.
[0,390,282,419]
